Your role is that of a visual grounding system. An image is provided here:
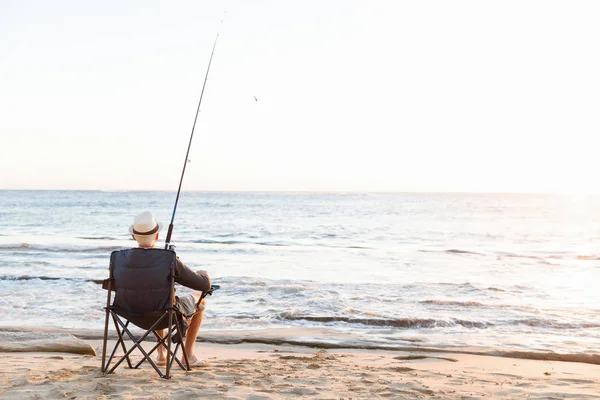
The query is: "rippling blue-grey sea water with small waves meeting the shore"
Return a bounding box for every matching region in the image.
[0,191,600,360]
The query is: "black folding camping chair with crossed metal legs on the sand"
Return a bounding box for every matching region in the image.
[102,248,218,379]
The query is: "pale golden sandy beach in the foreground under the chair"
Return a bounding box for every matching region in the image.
[0,328,600,399]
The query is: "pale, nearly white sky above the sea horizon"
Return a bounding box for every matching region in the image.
[0,0,600,192]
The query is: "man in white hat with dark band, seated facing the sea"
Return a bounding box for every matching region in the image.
[129,211,211,367]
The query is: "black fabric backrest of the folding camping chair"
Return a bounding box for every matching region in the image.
[110,248,177,316]
